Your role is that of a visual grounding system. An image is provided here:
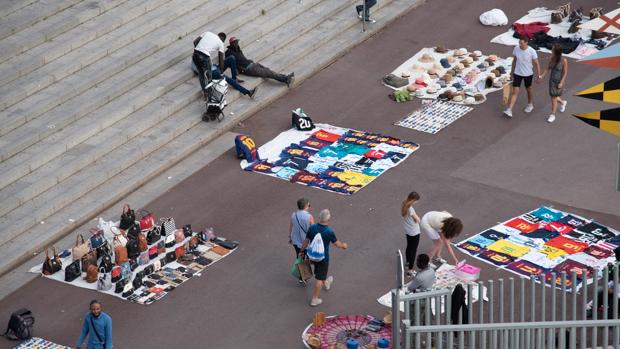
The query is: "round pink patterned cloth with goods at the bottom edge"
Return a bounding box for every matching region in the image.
[301,313,392,349]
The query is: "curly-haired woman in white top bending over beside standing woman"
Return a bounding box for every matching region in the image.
[420,211,463,265]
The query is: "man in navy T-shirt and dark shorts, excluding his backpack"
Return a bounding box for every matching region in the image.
[300,209,348,307]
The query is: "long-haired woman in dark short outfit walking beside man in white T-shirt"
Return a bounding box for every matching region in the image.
[541,44,568,122]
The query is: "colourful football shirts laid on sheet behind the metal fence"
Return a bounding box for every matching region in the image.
[456,207,620,288]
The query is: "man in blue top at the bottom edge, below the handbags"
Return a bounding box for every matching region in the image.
[75,300,112,349]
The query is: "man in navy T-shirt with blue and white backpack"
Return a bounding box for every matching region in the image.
[300,209,348,307]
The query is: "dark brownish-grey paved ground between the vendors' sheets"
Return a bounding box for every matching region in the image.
[0,0,620,348]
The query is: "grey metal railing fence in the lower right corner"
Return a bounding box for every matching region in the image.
[391,251,620,349]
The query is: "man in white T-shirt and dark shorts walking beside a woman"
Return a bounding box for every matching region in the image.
[504,36,540,117]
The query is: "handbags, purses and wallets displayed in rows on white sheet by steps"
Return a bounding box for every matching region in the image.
[30,205,238,304]
